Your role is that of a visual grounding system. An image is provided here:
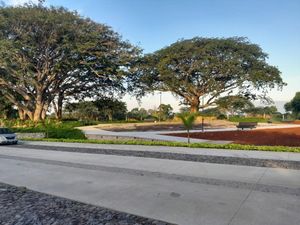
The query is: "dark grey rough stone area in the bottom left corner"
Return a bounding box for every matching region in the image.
[0,183,170,225]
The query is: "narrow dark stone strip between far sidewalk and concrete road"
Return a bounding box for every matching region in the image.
[8,145,300,170]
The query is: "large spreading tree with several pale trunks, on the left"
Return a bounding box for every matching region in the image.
[0,4,139,121]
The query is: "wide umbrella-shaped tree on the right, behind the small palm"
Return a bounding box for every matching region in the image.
[135,37,284,112]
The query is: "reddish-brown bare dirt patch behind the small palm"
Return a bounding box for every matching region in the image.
[168,127,300,146]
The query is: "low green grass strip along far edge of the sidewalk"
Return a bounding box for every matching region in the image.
[23,138,300,153]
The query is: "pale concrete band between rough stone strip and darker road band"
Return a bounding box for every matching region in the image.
[0,147,300,188]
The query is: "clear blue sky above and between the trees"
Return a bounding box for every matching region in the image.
[4,0,300,110]
